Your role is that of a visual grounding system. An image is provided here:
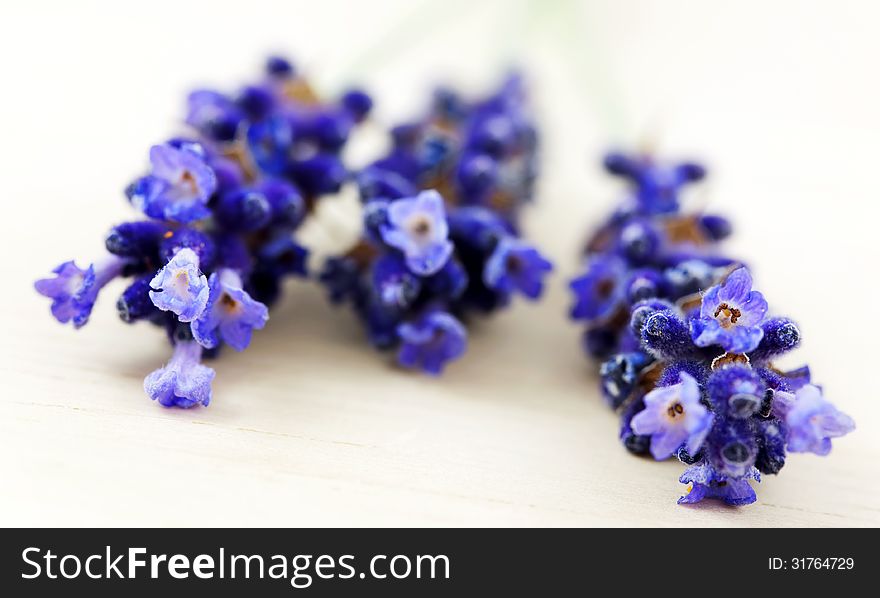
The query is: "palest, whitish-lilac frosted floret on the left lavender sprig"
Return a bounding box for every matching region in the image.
[150,248,210,322]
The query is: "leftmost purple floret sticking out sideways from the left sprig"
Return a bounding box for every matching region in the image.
[34,255,125,328]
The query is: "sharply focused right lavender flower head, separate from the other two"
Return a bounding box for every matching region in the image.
[571,154,855,505]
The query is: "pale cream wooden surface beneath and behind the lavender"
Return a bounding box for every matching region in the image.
[0,1,880,527]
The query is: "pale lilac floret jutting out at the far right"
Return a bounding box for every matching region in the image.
[772,384,856,456]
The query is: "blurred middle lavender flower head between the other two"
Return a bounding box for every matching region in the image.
[321,76,552,374]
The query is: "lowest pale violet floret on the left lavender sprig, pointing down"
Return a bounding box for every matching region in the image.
[144,340,214,408]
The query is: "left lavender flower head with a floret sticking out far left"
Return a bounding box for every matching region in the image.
[35,58,371,407]
